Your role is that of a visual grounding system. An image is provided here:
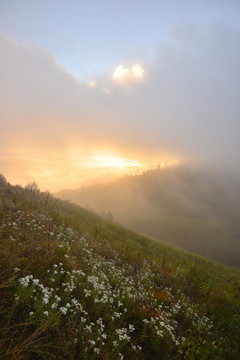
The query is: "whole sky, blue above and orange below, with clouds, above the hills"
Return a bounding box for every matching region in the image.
[0,0,240,192]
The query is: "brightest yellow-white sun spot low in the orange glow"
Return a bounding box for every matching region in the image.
[93,155,141,169]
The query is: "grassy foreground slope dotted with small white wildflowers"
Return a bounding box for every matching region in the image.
[0,179,240,360]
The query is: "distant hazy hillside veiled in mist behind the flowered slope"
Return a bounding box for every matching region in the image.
[57,165,240,267]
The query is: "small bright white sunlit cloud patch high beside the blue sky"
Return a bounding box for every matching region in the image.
[113,64,144,83]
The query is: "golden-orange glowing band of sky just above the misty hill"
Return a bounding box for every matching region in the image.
[3,148,181,192]
